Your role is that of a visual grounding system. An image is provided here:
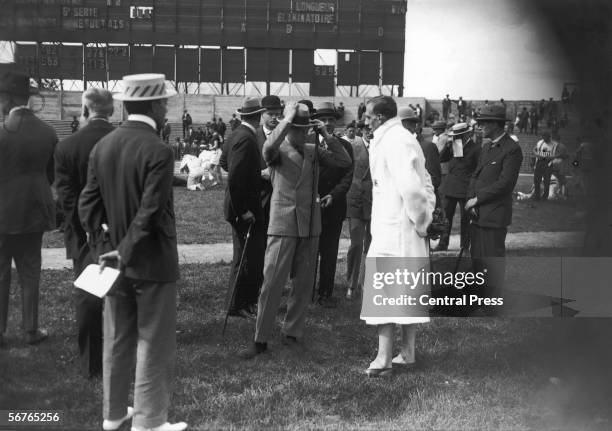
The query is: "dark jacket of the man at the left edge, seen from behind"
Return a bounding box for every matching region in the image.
[0,109,57,235]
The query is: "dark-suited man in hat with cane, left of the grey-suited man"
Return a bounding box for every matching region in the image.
[223,98,266,318]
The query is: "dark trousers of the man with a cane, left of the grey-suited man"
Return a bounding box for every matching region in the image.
[226,221,267,309]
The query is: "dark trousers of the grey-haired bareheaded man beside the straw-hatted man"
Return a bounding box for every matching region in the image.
[73,245,104,377]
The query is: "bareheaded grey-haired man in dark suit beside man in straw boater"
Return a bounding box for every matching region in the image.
[55,88,114,377]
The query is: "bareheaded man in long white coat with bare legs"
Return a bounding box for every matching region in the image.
[361,96,436,377]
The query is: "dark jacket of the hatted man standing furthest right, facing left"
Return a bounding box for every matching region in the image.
[467,134,523,228]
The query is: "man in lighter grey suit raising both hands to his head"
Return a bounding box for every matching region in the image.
[239,103,351,359]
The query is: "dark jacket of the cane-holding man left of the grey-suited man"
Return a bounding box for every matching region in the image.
[223,124,263,223]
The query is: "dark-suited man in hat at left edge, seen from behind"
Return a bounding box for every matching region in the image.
[0,71,57,347]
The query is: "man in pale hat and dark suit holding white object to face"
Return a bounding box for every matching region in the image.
[434,123,480,251]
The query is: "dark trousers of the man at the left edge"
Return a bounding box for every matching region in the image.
[0,232,43,334]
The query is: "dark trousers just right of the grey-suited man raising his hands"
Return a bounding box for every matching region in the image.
[319,213,346,297]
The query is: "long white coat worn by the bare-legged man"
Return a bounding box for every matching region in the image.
[361,118,436,325]
